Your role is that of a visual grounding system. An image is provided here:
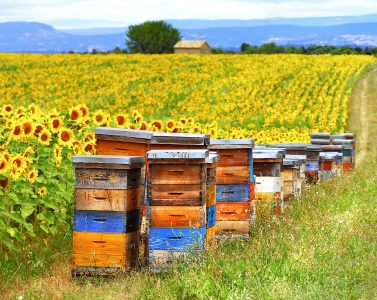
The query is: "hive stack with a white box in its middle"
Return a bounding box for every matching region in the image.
[253,147,285,219]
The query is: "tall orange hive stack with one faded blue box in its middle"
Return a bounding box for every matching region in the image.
[210,139,254,238]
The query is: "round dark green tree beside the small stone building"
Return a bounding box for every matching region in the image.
[126,21,181,54]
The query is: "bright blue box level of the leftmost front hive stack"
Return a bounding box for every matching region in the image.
[73,209,140,233]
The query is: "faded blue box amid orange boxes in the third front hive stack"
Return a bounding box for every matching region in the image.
[216,184,251,202]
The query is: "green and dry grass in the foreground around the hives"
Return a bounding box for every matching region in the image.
[0,66,377,299]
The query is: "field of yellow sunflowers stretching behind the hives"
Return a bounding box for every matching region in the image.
[0,54,374,251]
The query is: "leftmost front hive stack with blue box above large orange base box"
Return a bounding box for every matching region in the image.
[73,156,144,275]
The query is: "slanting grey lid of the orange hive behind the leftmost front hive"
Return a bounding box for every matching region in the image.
[95,127,153,144]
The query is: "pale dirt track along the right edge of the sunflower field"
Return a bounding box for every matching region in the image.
[349,66,377,165]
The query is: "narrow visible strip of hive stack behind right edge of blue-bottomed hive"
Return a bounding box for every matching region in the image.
[206,152,219,248]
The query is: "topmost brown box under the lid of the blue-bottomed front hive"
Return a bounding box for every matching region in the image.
[150,164,202,185]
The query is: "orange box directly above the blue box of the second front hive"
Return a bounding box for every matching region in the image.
[150,206,206,228]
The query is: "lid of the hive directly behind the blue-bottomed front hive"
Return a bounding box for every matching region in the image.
[152,132,210,146]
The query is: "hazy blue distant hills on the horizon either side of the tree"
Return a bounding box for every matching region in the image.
[0,19,377,53]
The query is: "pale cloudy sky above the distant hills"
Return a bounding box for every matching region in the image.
[0,0,377,29]
